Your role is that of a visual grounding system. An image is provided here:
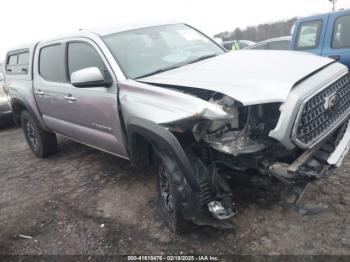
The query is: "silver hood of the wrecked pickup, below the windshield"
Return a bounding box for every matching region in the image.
[138,50,334,105]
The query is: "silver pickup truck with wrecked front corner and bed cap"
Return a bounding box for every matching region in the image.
[5,22,350,232]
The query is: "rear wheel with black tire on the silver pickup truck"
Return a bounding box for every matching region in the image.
[21,111,57,158]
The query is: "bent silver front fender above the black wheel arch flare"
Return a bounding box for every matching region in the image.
[118,80,231,124]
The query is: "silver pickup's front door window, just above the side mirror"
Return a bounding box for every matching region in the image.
[68,42,108,77]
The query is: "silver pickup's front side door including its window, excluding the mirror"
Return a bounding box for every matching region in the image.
[65,40,125,156]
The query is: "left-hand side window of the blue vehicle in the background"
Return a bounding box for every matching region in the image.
[296,20,322,49]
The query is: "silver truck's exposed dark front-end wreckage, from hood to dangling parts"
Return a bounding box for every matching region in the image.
[156,85,348,226]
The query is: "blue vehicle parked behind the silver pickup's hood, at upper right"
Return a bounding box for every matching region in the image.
[291,9,350,68]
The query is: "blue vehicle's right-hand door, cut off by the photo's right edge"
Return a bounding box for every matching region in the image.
[322,10,350,68]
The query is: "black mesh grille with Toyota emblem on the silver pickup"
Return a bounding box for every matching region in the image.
[294,74,350,147]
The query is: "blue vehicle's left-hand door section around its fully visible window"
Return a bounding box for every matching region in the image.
[292,15,329,55]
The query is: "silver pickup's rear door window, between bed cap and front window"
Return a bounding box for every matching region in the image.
[39,44,67,82]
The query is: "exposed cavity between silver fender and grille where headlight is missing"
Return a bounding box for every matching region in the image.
[193,93,278,156]
